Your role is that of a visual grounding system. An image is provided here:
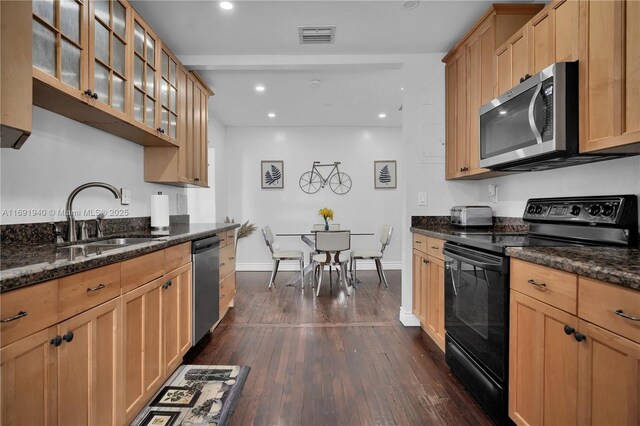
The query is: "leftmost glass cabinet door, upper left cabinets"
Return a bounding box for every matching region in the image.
[32,0,87,96]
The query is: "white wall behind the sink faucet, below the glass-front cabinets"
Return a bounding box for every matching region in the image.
[0,107,183,224]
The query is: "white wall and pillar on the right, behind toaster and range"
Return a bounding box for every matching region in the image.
[398,53,640,325]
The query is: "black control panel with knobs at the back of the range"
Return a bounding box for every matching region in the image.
[522,195,637,225]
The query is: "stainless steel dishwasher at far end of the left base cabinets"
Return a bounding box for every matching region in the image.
[191,236,220,345]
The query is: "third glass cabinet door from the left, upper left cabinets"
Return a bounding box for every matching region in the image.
[133,14,159,129]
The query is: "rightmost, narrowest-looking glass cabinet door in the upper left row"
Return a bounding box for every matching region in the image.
[160,48,178,140]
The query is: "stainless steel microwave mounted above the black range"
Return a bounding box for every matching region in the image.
[480,62,617,171]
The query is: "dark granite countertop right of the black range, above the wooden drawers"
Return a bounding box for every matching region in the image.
[507,247,640,291]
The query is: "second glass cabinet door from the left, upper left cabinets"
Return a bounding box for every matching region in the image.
[89,0,131,113]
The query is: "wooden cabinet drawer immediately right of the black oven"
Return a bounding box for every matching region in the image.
[511,259,578,315]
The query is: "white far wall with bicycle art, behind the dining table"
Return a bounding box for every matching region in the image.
[227,127,403,270]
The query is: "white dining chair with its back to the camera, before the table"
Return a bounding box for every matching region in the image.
[312,231,351,296]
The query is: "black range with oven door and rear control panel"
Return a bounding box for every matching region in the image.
[444,195,638,424]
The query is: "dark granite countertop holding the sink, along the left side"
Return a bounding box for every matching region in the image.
[0,223,240,292]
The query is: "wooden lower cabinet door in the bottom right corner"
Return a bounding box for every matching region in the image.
[578,320,640,425]
